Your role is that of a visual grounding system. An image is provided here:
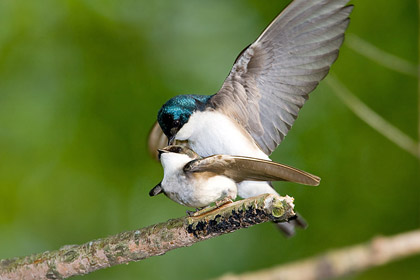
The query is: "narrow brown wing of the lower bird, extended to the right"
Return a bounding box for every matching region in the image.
[184,155,321,186]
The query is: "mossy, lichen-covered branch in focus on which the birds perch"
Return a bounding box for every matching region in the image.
[0,194,295,280]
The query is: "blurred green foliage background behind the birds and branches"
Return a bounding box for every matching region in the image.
[0,0,420,279]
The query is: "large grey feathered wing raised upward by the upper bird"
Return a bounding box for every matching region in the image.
[209,0,353,155]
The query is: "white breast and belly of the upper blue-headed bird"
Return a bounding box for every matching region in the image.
[176,111,278,198]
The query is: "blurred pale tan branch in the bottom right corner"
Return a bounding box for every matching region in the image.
[218,230,420,280]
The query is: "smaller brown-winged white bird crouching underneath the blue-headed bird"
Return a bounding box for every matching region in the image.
[149,145,320,208]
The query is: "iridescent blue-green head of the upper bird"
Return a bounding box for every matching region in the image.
[158,94,211,144]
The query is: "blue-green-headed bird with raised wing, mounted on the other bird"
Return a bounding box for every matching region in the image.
[148,0,353,235]
